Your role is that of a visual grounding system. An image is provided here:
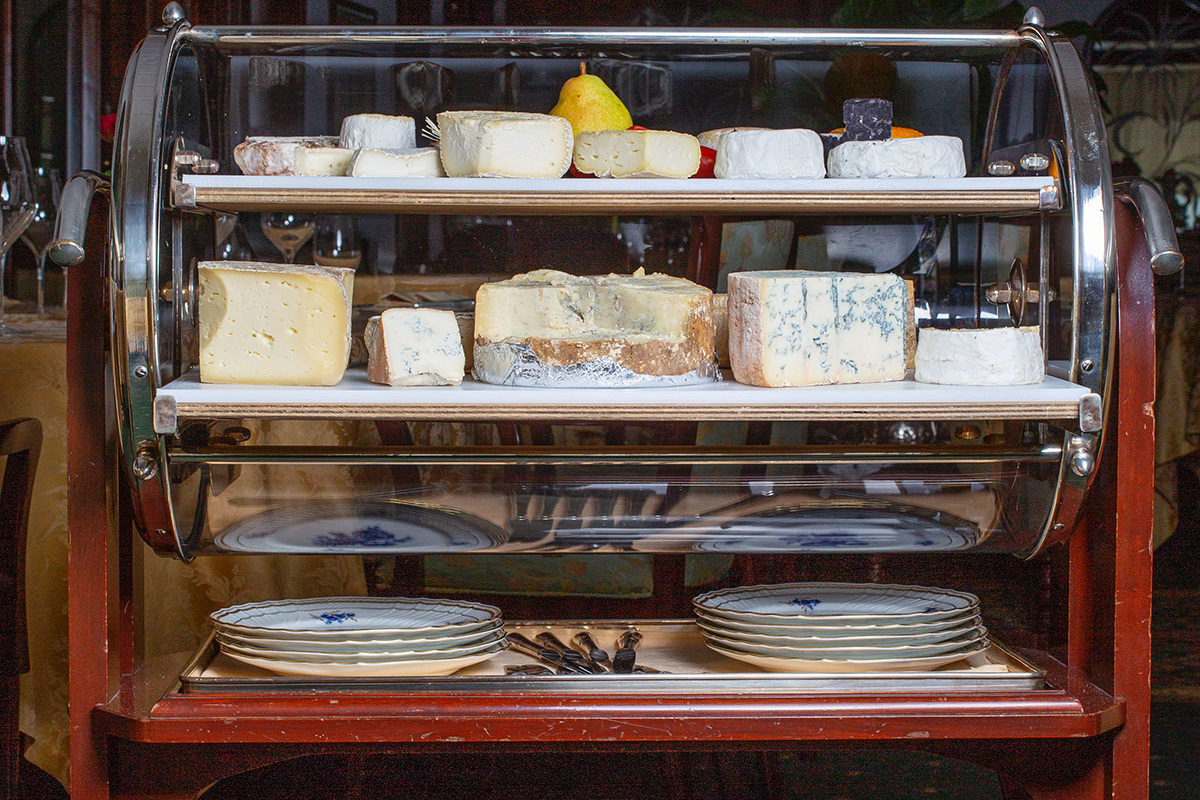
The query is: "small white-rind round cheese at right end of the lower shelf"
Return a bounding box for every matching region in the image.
[914,327,1045,386]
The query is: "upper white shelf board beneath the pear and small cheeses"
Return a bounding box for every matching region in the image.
[173,175,1063,216]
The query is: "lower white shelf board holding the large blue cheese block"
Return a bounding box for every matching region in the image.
[155,368,1099,433]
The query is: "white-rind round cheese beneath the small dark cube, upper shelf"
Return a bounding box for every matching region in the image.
[829,136,967,178]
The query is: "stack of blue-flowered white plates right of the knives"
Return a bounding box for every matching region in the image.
[692,583,989,673]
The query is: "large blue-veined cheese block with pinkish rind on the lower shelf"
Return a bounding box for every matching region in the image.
[728,270,907,386]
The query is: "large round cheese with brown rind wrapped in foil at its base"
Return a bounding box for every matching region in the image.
[473,270,720,386]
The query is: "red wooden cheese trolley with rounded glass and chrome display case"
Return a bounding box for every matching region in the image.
[54,4,1181,800]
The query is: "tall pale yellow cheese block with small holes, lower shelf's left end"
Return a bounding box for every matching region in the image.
[198,261,354,386]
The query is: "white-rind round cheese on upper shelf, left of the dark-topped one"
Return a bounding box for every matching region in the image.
[713,128,824,179]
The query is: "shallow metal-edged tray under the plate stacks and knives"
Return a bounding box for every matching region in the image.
[179,620,1045,694]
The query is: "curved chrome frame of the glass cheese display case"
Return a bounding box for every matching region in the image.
[109,20,1115,559]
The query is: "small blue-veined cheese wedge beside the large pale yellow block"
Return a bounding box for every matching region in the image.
[365,308,466,386]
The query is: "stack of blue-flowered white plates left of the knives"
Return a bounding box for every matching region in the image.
[210,597,508,678]
